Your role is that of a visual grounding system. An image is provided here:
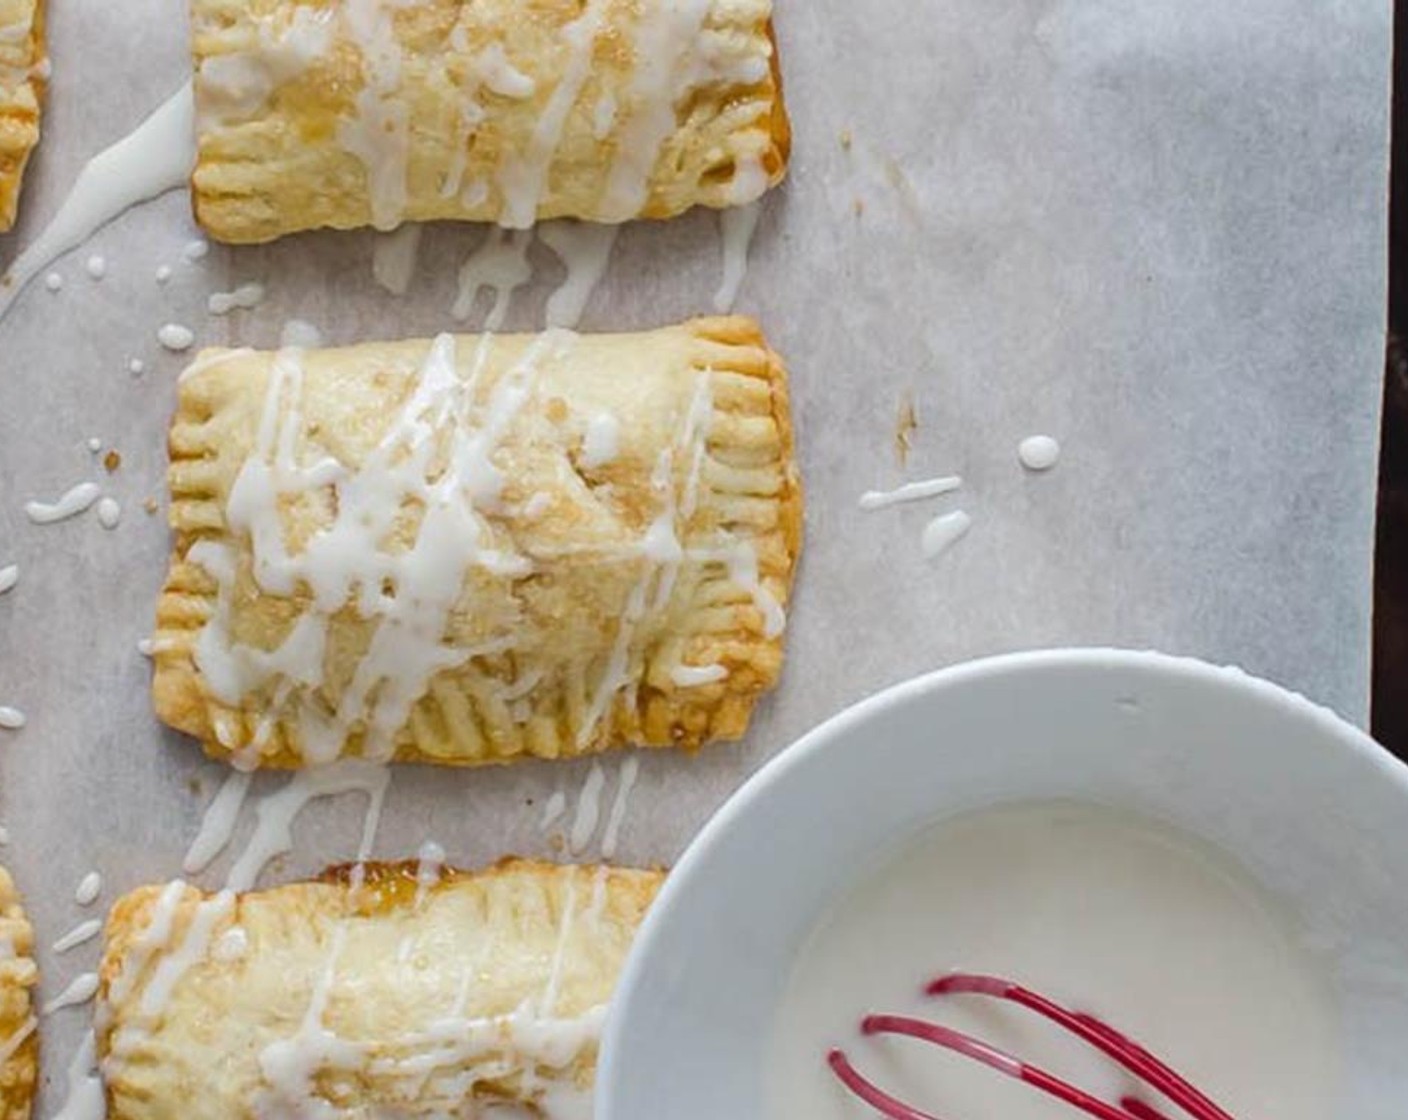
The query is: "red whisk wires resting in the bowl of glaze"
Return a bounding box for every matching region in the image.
[826,973,1232,1120]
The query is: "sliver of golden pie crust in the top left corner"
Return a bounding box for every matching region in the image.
[0,0,49,232]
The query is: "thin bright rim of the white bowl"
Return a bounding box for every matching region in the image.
[594,647,1408,1120]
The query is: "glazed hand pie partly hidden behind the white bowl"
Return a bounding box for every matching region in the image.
[96,861,663,1120]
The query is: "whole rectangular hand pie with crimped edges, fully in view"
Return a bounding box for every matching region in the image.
[152,318,801,768]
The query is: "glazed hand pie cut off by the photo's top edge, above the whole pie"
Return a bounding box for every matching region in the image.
[191,0,790,242]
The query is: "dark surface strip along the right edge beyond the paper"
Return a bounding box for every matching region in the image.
[1373,8,1408,759]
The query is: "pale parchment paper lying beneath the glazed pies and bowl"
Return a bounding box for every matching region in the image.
[0,0,1390,1116]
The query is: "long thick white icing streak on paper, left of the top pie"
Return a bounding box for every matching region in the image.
[0,82,196,317]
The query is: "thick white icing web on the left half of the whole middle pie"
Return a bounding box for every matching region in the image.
[190,332,574,762]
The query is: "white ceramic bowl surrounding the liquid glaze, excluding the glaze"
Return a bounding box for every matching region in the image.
[596,649,1408,1120]
